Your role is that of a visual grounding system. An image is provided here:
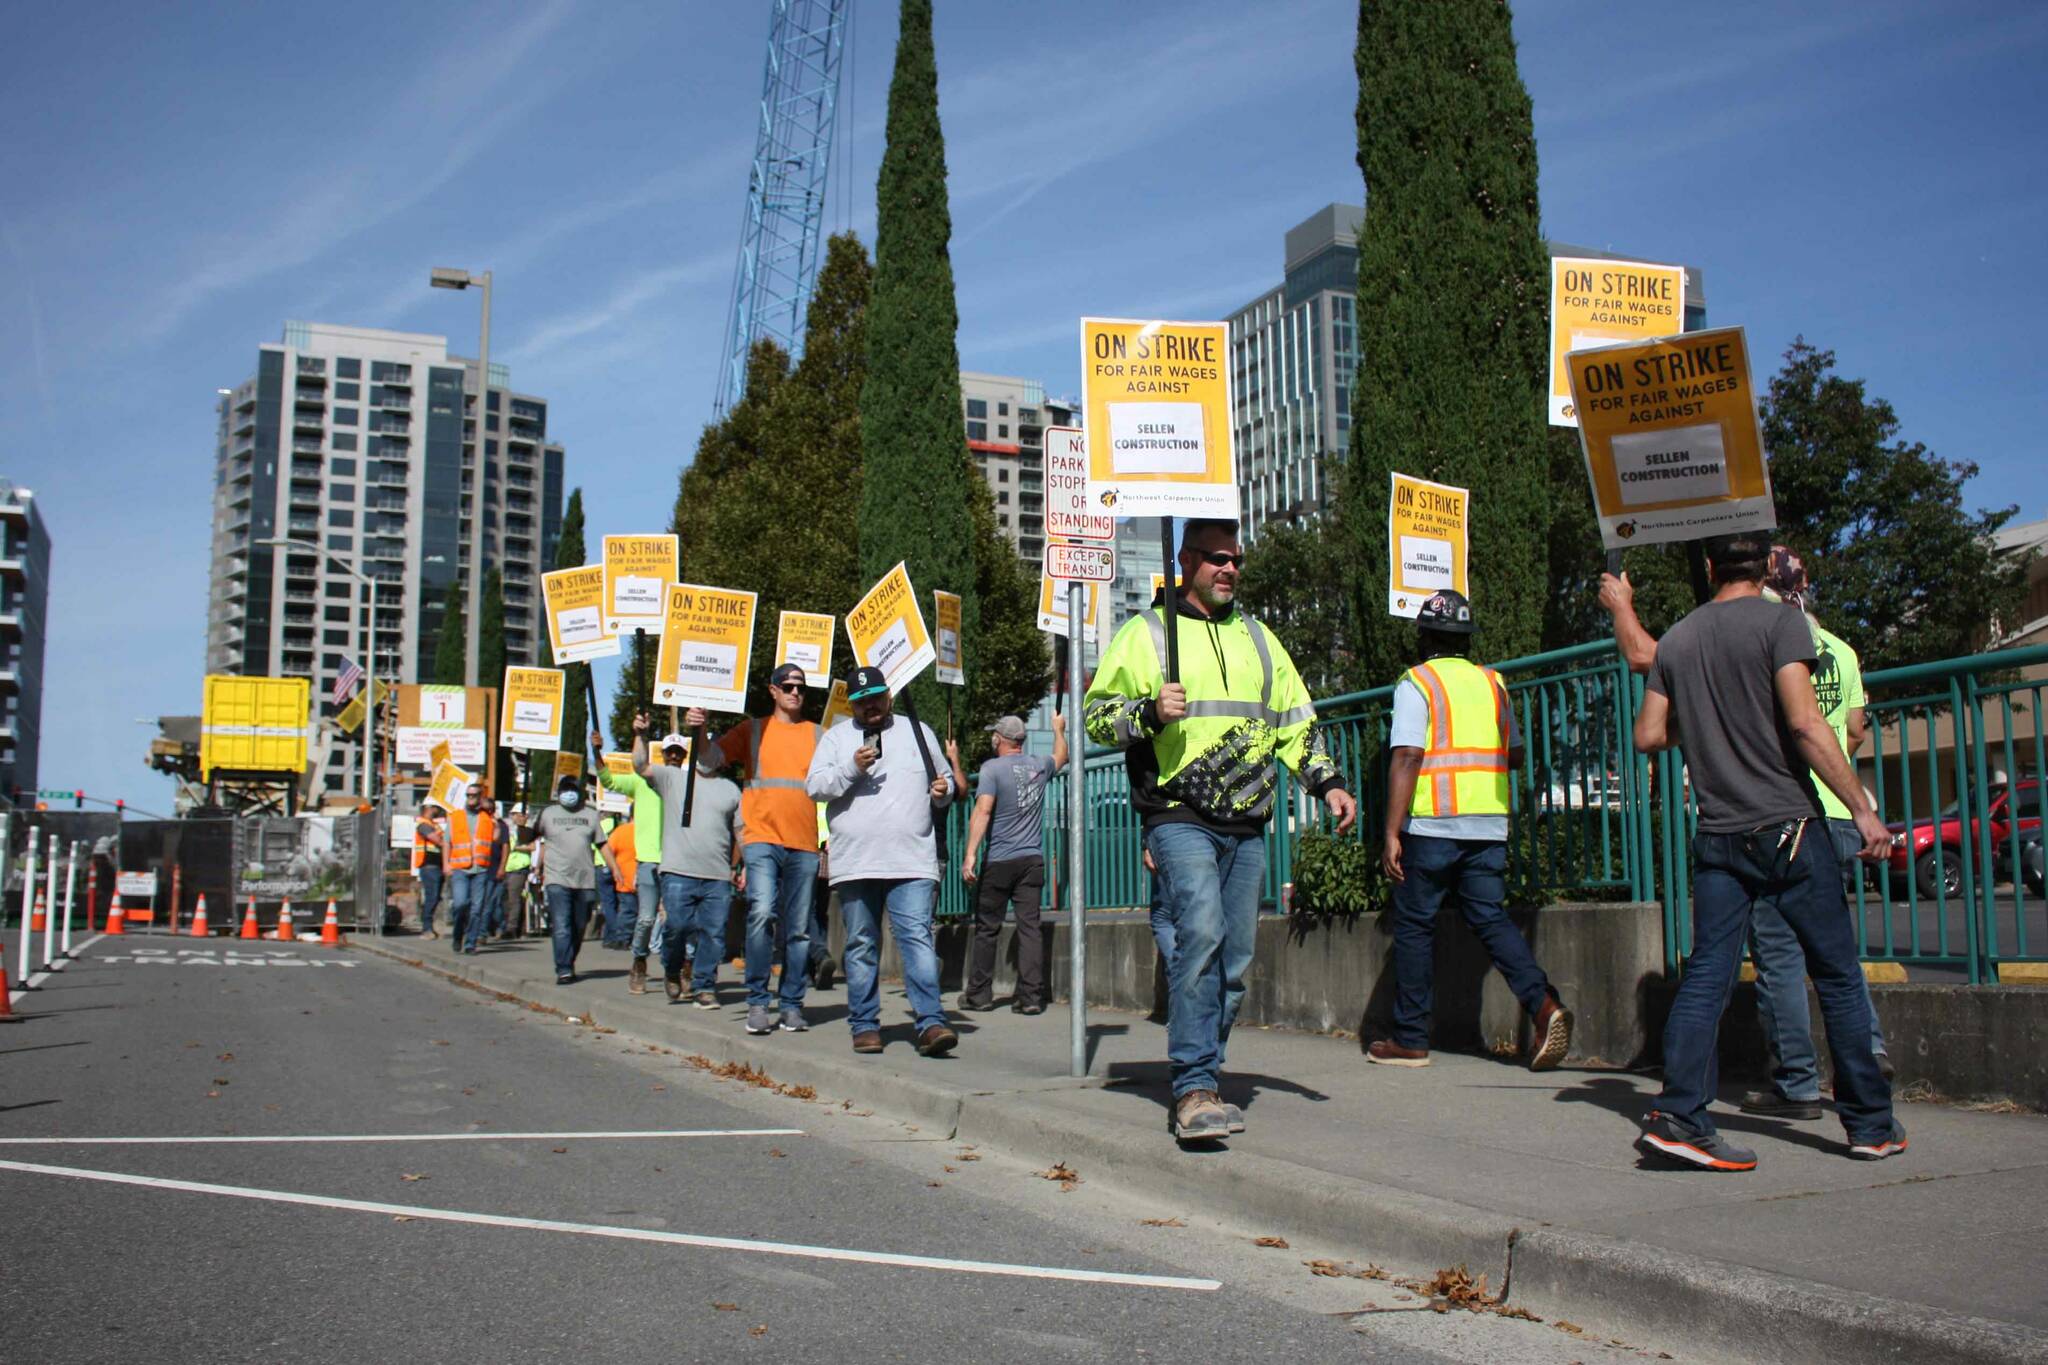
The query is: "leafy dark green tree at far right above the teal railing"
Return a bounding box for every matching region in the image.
[1759,338,2025,671]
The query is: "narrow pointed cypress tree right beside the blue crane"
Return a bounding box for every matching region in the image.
[860,0,989,732]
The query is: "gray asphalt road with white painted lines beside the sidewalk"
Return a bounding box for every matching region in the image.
[0,935,1669,1365]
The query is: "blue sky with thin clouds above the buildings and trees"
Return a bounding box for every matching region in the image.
[0,0,2048,808]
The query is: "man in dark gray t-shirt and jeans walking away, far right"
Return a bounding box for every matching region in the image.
[1634,532,1907,1171]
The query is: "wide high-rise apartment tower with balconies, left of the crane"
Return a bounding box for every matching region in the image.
[207,323,563,790]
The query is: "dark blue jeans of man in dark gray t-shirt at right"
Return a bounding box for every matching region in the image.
[1657,821,1892,1142]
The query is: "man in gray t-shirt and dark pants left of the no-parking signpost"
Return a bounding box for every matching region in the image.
[961,716,1067,1015]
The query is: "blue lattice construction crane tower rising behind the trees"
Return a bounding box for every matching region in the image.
[713,0,852,417]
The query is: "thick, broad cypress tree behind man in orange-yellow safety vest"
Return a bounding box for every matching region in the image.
[1346,0,1550,679]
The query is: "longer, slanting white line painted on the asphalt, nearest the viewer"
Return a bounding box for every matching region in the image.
[0,1160,1223,1291]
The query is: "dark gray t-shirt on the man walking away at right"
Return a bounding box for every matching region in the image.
[1647,598,1821,835]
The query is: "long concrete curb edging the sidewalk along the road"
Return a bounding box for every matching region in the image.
[350,939,2048,1365]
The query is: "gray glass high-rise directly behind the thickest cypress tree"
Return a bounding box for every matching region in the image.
[1229,205,1706,540]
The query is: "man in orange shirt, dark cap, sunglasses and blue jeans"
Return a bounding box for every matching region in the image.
[684,663,823,1033]
